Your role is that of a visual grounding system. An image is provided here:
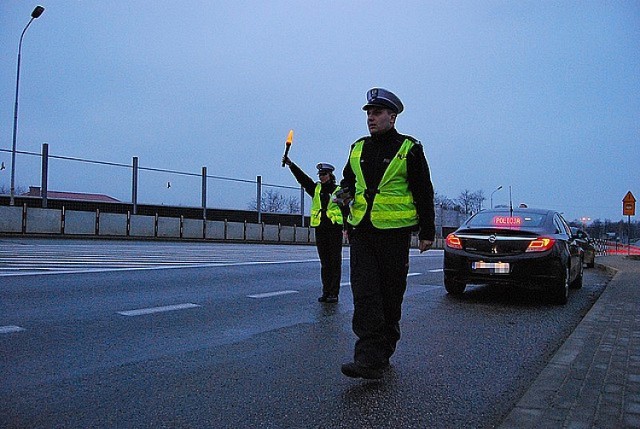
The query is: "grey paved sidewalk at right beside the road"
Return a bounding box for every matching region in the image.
[500,256,640,429]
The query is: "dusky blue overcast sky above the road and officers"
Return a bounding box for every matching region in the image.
[0,0,640,221]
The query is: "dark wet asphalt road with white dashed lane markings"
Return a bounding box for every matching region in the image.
[0,239,608,428]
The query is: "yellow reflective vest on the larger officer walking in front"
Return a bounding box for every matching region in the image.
[349,139,418,229]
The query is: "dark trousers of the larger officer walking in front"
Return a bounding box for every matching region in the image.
[350,229,411,367]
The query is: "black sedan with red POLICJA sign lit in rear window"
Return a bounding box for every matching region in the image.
[444,208,584,304]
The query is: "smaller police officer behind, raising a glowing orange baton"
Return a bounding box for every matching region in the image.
[282,156,343,303]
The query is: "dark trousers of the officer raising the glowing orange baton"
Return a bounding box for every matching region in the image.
[316,225,342,296]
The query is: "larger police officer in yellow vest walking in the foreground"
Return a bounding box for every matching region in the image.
[339,88,435,379]
